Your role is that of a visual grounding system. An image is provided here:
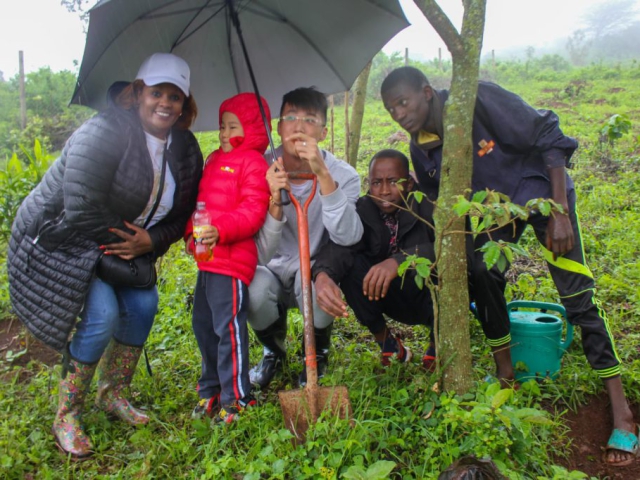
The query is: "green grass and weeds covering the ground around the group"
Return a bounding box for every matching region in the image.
[0,62,640,480]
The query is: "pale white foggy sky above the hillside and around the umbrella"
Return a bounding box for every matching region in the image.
[0,0,640,80]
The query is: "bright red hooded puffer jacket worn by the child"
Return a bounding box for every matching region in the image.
[185,93,271,285]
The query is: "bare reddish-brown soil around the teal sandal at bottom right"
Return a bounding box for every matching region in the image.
[554,394,640,480]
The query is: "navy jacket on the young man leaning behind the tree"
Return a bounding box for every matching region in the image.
[410,82,578,205]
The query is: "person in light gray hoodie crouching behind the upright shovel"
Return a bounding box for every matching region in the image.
[249,88,363,388]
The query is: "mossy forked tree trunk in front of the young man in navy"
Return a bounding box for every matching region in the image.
[414,0,486,394]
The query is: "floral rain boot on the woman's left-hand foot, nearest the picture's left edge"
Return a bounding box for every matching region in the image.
[51,359,97,460]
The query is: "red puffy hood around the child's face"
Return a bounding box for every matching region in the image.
[218,92,271,153]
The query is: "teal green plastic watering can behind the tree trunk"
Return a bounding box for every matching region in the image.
[507,300,573,382]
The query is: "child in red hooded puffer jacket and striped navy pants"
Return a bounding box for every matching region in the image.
[185,93,271,423]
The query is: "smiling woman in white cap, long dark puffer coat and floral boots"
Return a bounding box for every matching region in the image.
[8,53,203,458]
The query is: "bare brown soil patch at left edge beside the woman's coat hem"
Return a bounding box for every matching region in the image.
[0,318,60,382]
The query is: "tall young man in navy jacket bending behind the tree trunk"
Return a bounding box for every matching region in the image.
[381,67,638,466]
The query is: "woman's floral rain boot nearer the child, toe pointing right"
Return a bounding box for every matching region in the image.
[96,339,149,425]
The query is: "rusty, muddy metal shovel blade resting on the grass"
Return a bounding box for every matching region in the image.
[278,386,352,443]
